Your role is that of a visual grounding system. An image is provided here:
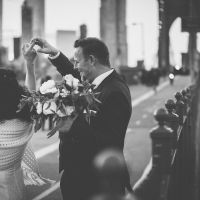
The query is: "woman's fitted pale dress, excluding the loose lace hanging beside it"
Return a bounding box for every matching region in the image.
[0,119,33,200]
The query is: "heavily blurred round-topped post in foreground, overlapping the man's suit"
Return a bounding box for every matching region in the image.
[90,149,137,200]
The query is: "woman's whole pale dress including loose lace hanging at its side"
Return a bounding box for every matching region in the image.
[0,119,50,200]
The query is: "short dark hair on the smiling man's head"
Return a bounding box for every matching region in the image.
[74,37,110,66]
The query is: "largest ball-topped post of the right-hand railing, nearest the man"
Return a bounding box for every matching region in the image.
[150,108,173,200]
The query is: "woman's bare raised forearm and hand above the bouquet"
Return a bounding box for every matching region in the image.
[22,43,37,91]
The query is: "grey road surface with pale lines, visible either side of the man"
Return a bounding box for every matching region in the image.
[28,76,190,200]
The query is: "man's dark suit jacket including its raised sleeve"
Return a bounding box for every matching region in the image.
[51,53,132,193]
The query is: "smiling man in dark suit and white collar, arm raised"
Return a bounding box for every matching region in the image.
[32,38,132,200]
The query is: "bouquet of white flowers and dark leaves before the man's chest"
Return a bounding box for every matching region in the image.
[19,74,101,137]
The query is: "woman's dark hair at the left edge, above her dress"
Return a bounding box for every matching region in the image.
[0,68,30,121]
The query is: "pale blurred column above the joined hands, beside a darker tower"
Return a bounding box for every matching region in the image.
[27,0,44,37]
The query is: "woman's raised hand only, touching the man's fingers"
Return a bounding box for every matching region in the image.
[22,43,37,64]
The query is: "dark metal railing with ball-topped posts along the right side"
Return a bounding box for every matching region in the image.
[134,80,200,200]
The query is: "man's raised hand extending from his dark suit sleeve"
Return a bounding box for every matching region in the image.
[31,38,59,56]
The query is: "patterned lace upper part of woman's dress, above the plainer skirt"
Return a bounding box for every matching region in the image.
[0,119,33,172]
